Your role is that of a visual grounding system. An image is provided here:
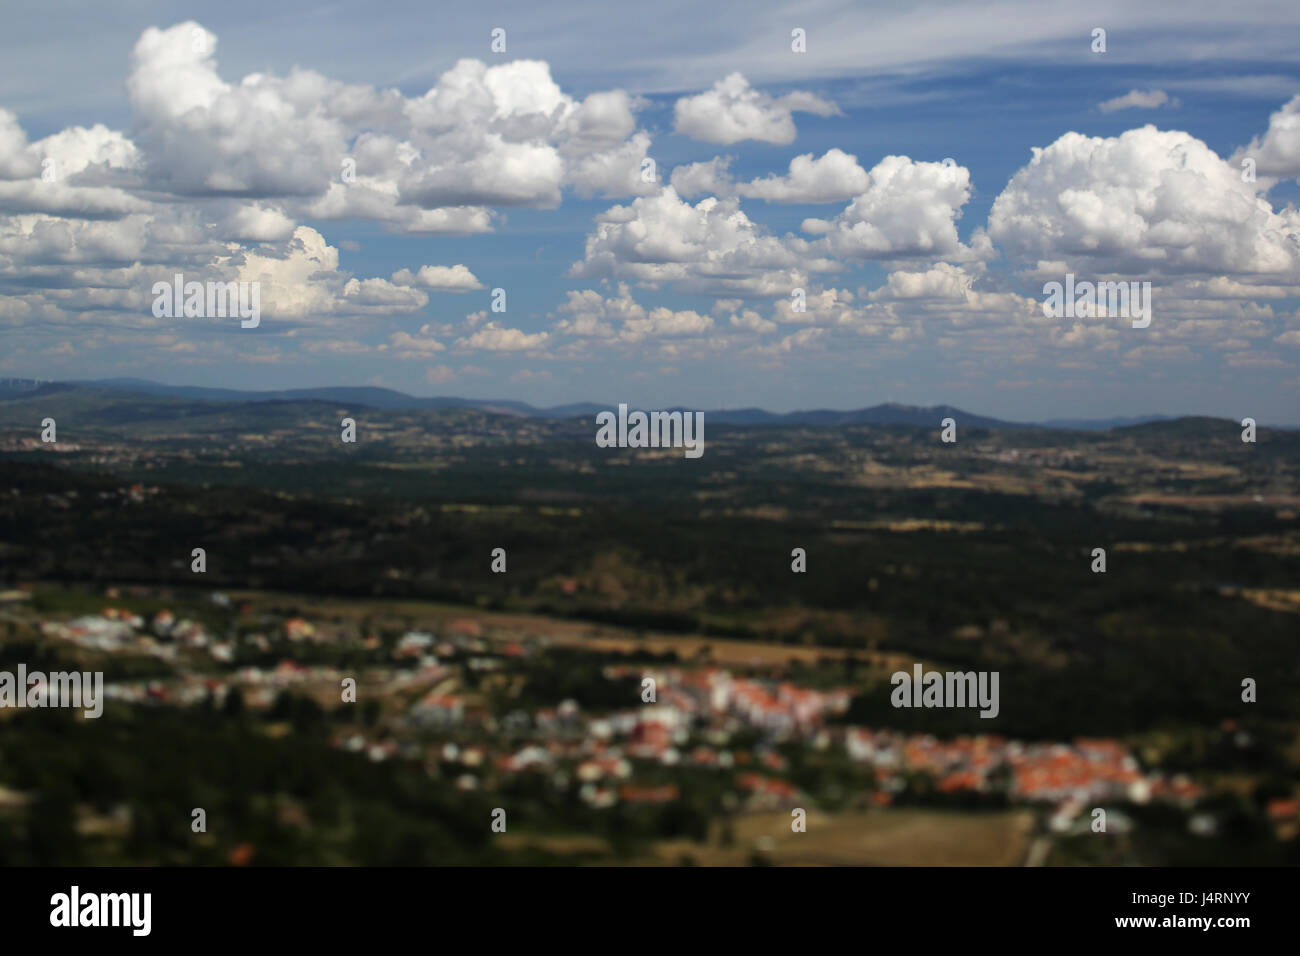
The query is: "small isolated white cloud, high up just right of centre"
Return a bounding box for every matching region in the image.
[673,73,840,144]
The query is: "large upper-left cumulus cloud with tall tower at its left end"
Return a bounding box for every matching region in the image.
[120,22,650,218]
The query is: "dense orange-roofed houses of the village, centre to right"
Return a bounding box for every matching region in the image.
[392,666,1201,806]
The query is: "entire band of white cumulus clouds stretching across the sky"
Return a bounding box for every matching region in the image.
[0,23,1300,384]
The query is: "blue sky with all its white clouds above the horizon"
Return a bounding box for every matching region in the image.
[0,0,1300,424]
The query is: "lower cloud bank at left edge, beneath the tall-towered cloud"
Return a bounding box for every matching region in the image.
[0,101,428,335]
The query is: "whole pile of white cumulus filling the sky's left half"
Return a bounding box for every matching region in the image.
[0,22,658,354]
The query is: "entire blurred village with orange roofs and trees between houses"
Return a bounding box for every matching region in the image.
[10,592,1248,848]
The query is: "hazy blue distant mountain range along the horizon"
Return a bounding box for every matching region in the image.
[0,378,1227,431]
